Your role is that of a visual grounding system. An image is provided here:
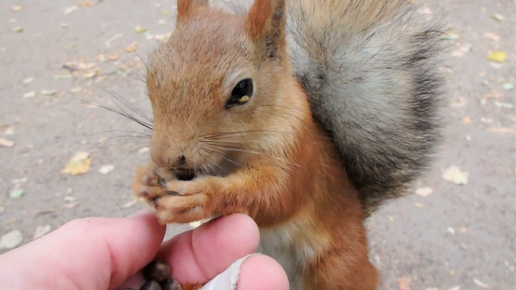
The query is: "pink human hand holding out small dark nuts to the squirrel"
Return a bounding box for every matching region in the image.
[0,214,288,290]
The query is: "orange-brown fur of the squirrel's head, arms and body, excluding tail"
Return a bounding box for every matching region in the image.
[132,0,378,290]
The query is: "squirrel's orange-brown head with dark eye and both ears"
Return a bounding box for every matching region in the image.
[147,0,291,169]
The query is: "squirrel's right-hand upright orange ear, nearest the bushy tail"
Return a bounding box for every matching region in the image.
[246,0,285,57]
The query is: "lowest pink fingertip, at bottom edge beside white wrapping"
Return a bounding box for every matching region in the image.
[237,255,289,290]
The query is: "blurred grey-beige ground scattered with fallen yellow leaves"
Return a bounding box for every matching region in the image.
[0,0,516,290]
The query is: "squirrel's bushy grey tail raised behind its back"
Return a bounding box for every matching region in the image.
[216,0,443,214]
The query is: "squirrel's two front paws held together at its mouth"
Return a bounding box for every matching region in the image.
[132,167,217,223]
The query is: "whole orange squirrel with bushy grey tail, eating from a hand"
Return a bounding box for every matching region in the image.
[131,0,443,290]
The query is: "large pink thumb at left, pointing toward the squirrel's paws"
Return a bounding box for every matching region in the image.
[0,214,166,290]
